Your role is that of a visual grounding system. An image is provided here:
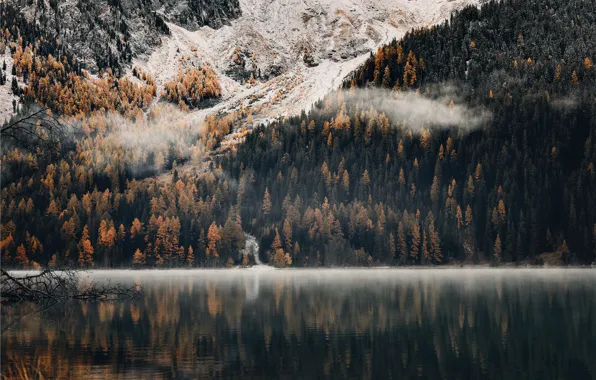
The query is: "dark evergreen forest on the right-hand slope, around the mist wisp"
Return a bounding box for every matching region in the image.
[224,0,596,265]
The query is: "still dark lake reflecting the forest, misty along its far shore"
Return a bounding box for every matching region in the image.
[1,268,596,379]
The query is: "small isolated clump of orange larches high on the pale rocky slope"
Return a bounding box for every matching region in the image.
[161,66,221,110]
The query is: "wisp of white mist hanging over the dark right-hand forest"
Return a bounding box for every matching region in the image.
[344,85,492,132]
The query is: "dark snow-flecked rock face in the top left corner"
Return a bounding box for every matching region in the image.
[0,0,241,72]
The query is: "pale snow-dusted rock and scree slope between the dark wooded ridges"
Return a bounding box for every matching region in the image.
[134,0,479,118]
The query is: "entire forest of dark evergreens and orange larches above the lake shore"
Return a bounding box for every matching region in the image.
[0,0,596,267]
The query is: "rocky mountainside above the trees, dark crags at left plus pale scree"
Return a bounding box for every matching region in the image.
[0,0,479,123]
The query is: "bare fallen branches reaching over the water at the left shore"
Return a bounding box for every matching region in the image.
[0,269,141,304]
